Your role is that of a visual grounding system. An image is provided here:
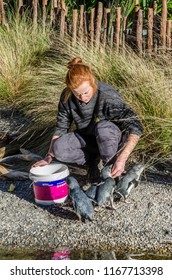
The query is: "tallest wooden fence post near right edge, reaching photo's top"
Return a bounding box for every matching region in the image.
[160,0,167,49]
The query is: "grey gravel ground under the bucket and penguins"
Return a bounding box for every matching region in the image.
[0,110,172,256]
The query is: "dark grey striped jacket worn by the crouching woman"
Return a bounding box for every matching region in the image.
[54,82,143,136]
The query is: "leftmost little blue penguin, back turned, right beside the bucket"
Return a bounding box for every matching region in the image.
[67,176,94,221]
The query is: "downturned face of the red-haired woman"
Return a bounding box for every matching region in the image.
[72,82,94,103]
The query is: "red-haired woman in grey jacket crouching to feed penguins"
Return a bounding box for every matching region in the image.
[34,57,143,182]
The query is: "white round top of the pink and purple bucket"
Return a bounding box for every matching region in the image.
[29,163,69,182]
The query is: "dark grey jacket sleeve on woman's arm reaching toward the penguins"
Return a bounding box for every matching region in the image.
[108,92,143,136]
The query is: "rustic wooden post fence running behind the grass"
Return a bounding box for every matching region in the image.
[0,0,172,55]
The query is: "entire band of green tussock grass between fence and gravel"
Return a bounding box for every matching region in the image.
[0,14,172,164]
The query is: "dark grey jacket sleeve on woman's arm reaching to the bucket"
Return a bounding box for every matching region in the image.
[54,92,72,136]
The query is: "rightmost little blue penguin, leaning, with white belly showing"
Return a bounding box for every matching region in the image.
[114,163,144,201]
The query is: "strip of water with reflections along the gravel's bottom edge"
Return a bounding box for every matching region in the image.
[0,247,172,260]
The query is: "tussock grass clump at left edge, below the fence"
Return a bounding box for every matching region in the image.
[0,13,49,104]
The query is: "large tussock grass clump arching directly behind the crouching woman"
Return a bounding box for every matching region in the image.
[17,39,172,161]
